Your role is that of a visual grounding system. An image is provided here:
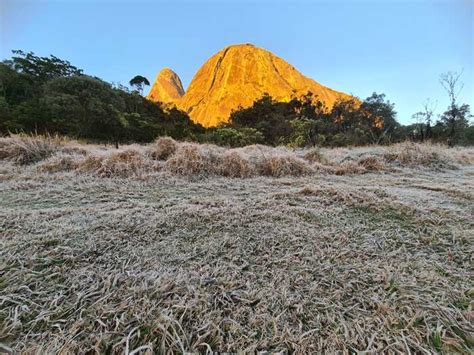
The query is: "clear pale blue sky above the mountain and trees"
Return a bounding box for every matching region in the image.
[0,0,474,123]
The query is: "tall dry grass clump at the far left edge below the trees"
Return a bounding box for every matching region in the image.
[0,134,60,165]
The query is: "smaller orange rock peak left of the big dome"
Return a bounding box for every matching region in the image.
[147,68,184,104]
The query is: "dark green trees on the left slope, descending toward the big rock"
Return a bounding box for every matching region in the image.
[0,51,204,144]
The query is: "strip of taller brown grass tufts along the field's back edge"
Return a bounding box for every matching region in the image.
[0,135,474,178]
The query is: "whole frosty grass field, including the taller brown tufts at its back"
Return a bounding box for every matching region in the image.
[0,137,474,354]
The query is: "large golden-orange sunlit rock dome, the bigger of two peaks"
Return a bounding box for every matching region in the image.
[148,44,349,127]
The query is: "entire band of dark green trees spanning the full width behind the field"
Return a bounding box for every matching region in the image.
[0,51,474,147]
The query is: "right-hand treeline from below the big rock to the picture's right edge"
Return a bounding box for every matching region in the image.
[206,87,474,147]
